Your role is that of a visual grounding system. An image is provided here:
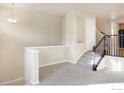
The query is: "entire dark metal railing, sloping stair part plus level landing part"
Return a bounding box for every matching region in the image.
[92,32,124,71]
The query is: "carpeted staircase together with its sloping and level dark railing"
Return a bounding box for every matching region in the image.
[78,30,124,71]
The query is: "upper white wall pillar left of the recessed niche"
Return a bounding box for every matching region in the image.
[65,11,77,45]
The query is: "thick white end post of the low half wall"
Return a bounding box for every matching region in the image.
[25,48,40,85]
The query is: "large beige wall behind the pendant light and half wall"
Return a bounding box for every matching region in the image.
[0,5,61,83]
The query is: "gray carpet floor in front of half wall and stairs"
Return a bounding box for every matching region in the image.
[40,63,124,85]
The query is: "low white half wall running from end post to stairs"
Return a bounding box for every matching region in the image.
[33,43,87,66]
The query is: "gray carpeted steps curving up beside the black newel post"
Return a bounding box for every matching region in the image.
[78,51,102,69]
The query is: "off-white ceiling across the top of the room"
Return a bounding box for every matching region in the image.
[0,3,124,19]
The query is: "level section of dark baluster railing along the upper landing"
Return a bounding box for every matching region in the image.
[106,34,124,57]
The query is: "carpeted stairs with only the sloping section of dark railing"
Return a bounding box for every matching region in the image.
[78,32,106,71]
